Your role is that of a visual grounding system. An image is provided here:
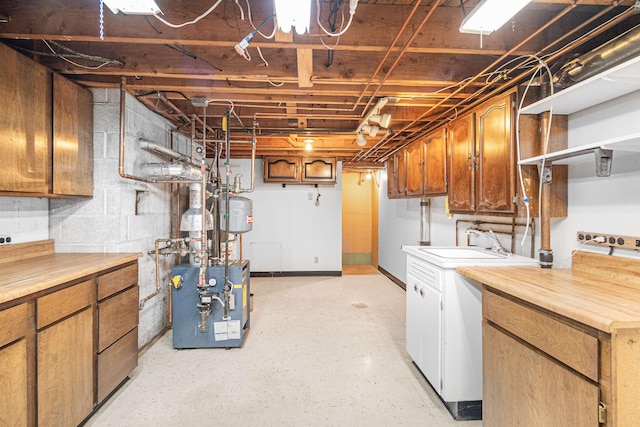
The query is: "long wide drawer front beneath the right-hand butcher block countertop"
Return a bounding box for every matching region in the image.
[482,290,598,382]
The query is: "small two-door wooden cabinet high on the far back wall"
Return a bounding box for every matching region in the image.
[263,156,337,184]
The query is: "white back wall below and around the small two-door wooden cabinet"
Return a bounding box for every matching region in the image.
[231,159,342,272]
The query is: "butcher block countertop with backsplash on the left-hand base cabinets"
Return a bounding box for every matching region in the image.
[0,240,142,305]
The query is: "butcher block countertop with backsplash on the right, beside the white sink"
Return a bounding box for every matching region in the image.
[457,252,640,333]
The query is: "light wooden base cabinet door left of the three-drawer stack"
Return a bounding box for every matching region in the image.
[37,308,93,426]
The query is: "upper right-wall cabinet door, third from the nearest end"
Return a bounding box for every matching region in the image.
[424,129,447,196]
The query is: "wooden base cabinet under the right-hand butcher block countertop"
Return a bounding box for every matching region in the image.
[482,286,640,427]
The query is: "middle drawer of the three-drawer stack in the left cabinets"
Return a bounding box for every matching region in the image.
[98,286,138,353]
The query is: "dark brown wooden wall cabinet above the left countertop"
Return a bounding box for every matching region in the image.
[0,44,93,197]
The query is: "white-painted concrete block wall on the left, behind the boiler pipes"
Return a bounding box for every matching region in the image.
[49,89,191,347]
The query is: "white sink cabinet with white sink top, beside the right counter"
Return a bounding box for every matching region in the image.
[403,246,537,420]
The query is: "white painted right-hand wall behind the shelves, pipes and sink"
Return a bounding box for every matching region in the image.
[379,91,640,281]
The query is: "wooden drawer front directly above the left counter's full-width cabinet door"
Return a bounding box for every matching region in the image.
[36,280,93,329]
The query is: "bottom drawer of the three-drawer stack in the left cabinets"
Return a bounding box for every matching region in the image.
[98,328,138,402]
